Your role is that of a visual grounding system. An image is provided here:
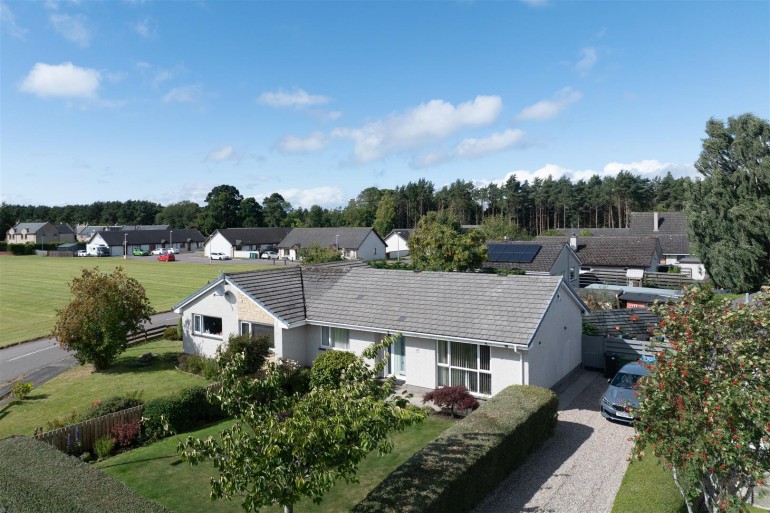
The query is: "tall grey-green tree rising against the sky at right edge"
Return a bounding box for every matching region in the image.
[685,114,770,292]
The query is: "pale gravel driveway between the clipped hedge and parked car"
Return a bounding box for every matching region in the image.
[473,371,634,513]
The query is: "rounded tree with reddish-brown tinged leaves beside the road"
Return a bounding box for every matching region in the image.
[52,267,154,371]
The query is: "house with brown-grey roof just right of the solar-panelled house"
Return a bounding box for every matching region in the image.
[535,235,663,274]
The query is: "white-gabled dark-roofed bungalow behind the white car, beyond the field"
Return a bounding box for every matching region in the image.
[203,228,292,258]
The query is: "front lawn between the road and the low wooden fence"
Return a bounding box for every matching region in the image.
[0,340,207,438]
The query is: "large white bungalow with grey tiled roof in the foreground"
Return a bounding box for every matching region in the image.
[174,262,588,396]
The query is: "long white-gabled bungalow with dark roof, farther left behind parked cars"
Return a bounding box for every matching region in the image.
[86,229,206,256]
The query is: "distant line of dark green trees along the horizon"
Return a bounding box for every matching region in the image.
[0,171,691,235]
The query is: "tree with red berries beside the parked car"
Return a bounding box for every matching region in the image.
[635,288,770,512]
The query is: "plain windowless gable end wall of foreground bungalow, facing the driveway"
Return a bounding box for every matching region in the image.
[524,287,582,388]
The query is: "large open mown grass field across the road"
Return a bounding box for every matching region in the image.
[0,256,273,347]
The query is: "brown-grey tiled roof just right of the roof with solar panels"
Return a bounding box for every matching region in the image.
[535,236,659,268]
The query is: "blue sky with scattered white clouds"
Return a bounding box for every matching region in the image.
[0,0,770,208]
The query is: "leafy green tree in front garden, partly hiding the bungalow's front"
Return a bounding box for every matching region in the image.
[179,337,424,511]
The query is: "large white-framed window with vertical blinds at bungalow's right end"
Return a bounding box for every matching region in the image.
[436,340,492,395]
